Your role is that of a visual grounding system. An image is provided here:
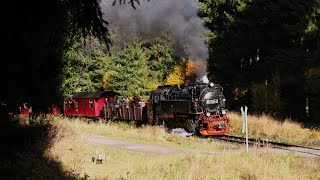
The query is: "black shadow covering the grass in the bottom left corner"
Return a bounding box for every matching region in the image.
[0,116,80,179]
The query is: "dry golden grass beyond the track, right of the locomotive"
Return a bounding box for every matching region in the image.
[229,113,320,146]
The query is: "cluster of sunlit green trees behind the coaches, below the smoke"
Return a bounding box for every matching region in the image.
[62,27,173,96]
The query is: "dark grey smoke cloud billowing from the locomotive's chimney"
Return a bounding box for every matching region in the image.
[101,0,208,76]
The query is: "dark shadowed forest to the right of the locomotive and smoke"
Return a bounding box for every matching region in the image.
[201,0,320,122]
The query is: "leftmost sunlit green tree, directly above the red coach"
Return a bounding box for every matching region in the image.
[61,37,110,96]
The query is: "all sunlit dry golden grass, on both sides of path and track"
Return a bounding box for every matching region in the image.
[31,113,320,180]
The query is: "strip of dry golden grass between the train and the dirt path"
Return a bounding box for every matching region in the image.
[50,117,239,150]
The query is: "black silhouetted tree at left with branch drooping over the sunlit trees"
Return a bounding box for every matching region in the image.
[0,0,117,119]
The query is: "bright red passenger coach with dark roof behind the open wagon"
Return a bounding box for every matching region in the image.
[63,91,116,117]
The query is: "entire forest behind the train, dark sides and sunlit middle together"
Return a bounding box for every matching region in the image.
[0,0,320,124]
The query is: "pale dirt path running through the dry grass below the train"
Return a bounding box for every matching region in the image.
[85,134,319,158]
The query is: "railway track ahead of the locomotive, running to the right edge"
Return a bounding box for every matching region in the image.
[211,135,320,157]
